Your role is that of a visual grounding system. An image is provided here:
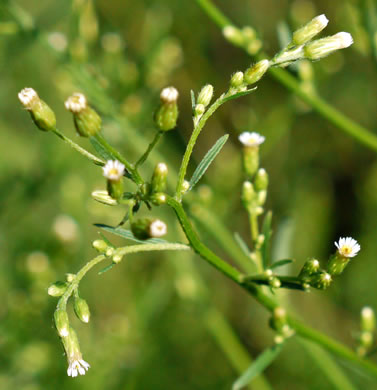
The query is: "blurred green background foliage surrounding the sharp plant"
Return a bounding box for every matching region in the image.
[0,0,377,390]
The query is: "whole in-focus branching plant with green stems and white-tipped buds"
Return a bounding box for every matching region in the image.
[18,15,377,378]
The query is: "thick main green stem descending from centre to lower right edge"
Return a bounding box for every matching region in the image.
[167,197,377,378]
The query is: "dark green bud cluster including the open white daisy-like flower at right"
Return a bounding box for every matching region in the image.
[298,237,360,290]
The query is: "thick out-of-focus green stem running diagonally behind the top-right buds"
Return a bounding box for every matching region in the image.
[196,0,377,151]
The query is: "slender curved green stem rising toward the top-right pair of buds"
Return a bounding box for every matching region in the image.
[175,93,230,202]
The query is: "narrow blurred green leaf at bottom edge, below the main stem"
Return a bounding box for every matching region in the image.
[232,344,283,390]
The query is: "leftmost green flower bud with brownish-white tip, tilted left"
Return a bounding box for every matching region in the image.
[18,88,56,131]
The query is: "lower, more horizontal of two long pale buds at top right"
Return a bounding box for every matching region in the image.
[304,32,353,60]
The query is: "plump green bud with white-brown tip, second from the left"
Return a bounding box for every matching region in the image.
[65,92,102,137]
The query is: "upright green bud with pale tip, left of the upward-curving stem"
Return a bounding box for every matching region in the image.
[154,87,178,131]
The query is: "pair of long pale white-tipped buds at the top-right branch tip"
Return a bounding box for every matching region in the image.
[271,15,353,66]
